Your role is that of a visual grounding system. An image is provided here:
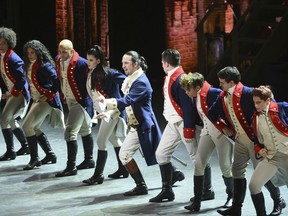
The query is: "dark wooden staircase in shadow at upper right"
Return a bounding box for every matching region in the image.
[204,0,288,86]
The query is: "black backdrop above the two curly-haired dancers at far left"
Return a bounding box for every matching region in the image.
[0,0,57,56]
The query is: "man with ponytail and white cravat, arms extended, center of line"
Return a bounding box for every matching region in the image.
[98,51,161,196]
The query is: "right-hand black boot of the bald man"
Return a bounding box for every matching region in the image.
[77,134,95,170]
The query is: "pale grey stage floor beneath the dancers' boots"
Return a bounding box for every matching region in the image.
[0,120,288,216]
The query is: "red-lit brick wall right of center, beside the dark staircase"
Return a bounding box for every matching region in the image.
[166,0,240,72]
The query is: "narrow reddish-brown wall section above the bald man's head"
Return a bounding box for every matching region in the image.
[56,0,99,57]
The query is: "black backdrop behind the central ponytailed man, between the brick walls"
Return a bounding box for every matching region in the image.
[108,0,166,125]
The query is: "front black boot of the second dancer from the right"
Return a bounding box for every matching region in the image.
[217,178,247,216]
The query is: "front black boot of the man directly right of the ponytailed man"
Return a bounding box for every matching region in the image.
[149,163,175,202]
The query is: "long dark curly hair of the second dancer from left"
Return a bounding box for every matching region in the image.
[23,40,55,70]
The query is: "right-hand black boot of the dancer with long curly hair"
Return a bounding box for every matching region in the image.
[37,133,57,165]
